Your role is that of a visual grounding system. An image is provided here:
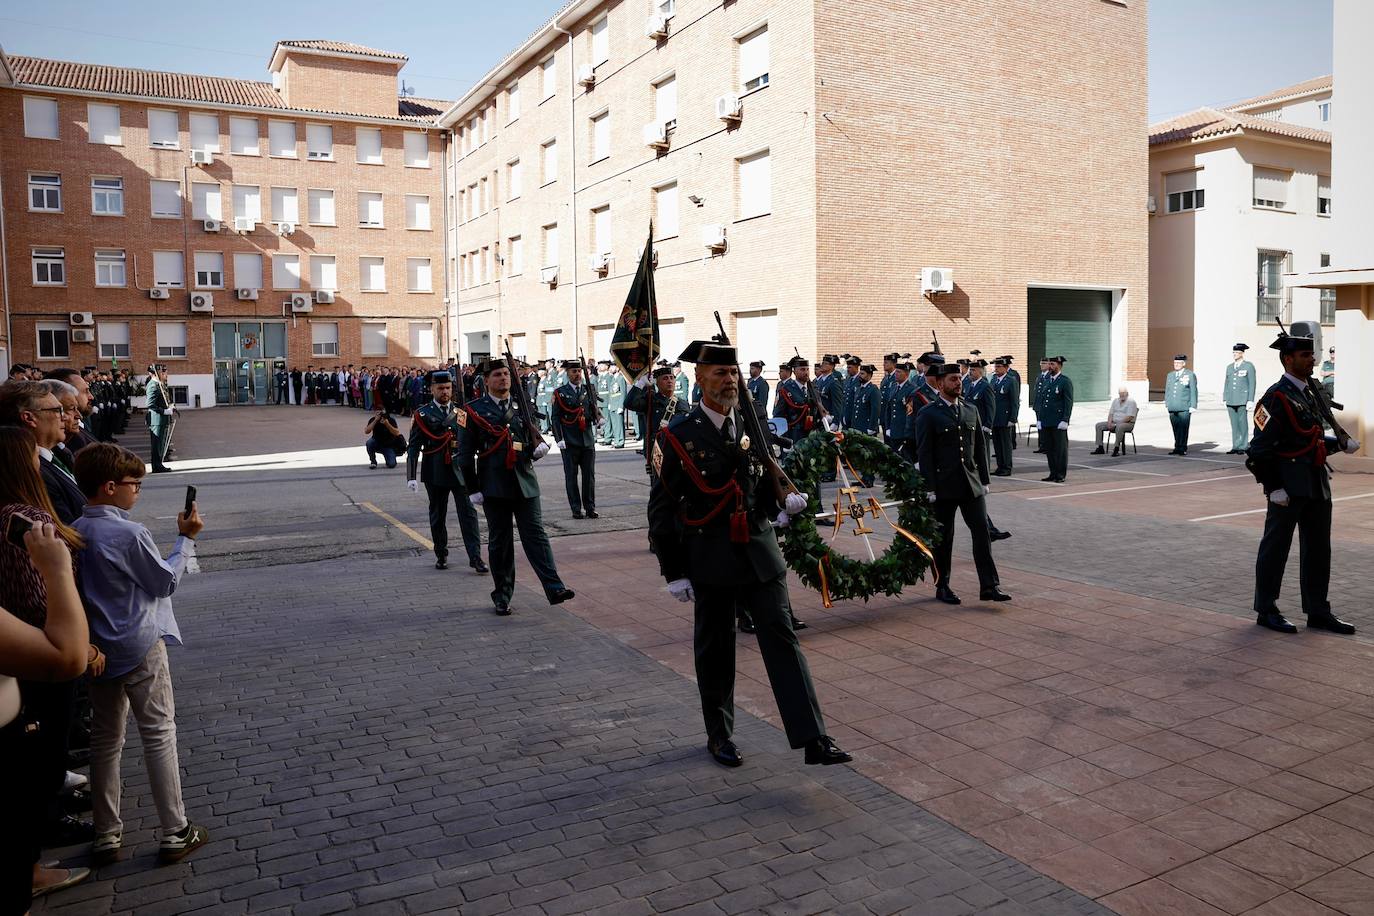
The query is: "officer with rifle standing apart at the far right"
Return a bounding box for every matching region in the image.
[1245,334,1360,634]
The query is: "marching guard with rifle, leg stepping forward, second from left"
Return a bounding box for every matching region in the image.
[458,358,573,617]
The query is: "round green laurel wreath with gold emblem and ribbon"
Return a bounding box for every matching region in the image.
[782,430,940,602]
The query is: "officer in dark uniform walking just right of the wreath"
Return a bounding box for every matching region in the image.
[916,363,1011,604]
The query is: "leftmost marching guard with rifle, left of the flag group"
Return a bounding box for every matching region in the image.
[405,372,488,573]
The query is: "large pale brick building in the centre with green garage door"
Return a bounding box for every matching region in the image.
[440,0,1149,400]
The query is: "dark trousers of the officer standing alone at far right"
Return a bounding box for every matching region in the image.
[1254,497,1331,617]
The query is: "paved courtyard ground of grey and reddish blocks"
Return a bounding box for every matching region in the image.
[34,408,1374,916]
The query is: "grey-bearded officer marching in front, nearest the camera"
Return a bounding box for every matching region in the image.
[649,341,852,766]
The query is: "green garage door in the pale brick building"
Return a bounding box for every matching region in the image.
[1026,290,1113,401]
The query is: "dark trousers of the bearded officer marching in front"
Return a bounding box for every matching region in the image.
[692,574,826,747]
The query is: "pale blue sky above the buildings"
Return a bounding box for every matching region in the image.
[0,0,1331,121]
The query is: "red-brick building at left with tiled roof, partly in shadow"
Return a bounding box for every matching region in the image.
[0,41,448,407]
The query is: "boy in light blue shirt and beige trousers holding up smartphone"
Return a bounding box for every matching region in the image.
[73,442,209,864]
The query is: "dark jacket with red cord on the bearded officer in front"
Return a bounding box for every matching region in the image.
[649,407,787,585]
